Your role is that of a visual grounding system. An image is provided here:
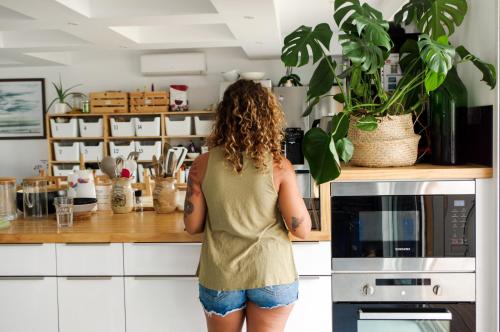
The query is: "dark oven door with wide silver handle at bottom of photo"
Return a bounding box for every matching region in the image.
[333,303,475,332]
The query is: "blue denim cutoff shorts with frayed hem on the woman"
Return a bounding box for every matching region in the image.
[199,281,299,317]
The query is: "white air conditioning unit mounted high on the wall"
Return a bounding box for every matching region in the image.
[141,53,207,76]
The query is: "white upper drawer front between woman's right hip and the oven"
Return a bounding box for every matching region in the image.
[292,241,332,276]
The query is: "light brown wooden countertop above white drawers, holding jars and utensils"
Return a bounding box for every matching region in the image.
[0,211,325,243]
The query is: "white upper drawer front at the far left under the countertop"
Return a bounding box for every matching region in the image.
[0,243,56,276]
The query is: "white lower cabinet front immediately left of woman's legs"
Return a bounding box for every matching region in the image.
[125,277,206,332]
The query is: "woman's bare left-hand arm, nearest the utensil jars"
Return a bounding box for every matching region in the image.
[184,153,208,234]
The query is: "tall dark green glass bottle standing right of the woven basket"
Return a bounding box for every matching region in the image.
[430,67,468,165]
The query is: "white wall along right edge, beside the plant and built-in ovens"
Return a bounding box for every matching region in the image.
[453,0,500,332]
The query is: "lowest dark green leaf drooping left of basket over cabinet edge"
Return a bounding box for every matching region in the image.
[302,128,340,184]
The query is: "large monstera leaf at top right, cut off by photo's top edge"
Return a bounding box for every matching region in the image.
[394,0,467,40]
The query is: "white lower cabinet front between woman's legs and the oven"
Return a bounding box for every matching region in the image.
[285,276,332,332]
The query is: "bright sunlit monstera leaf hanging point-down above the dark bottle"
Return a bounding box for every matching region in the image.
[418,35,455,93]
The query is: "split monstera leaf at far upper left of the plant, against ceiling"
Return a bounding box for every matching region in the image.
[281,23,333,67]
